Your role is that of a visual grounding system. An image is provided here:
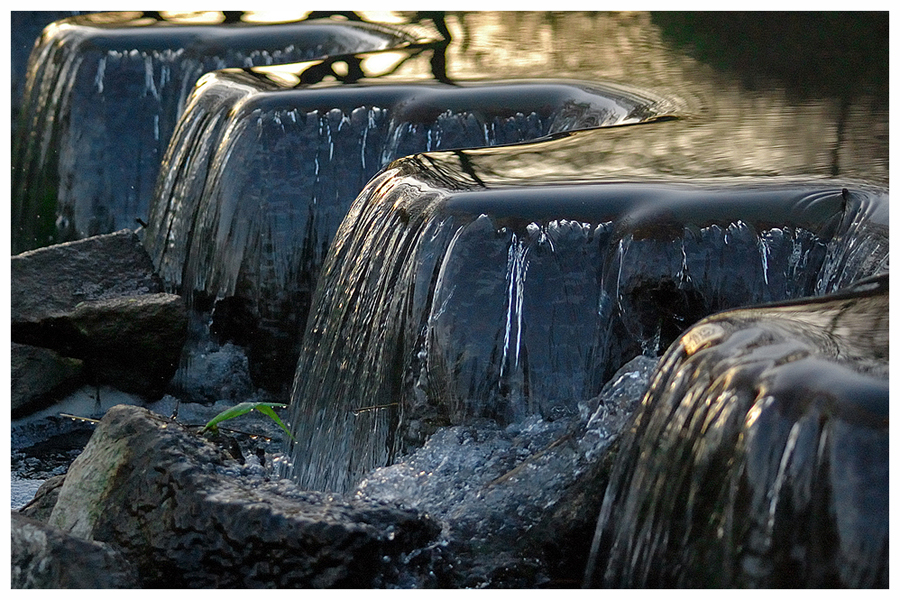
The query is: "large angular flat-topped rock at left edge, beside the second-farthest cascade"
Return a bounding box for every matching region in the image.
[12,230,187,398]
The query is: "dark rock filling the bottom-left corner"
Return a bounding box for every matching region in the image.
[10,511,137,589]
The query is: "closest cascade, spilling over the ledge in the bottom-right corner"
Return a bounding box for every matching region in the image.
[586,275,889,587]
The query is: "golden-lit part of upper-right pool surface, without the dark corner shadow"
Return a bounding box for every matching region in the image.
[434,12,888,184]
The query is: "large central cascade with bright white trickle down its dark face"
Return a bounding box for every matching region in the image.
[291,139,887,491]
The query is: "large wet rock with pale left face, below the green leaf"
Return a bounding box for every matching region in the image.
[50,406,438,587]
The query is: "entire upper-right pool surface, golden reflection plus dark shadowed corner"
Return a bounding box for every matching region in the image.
[436,12,888,183]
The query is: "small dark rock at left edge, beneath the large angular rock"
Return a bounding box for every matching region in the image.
[10,342,83,417]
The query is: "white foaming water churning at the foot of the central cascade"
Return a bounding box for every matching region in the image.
[356,356,657,586]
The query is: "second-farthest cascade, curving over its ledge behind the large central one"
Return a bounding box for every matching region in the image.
[146,47,676,391]
